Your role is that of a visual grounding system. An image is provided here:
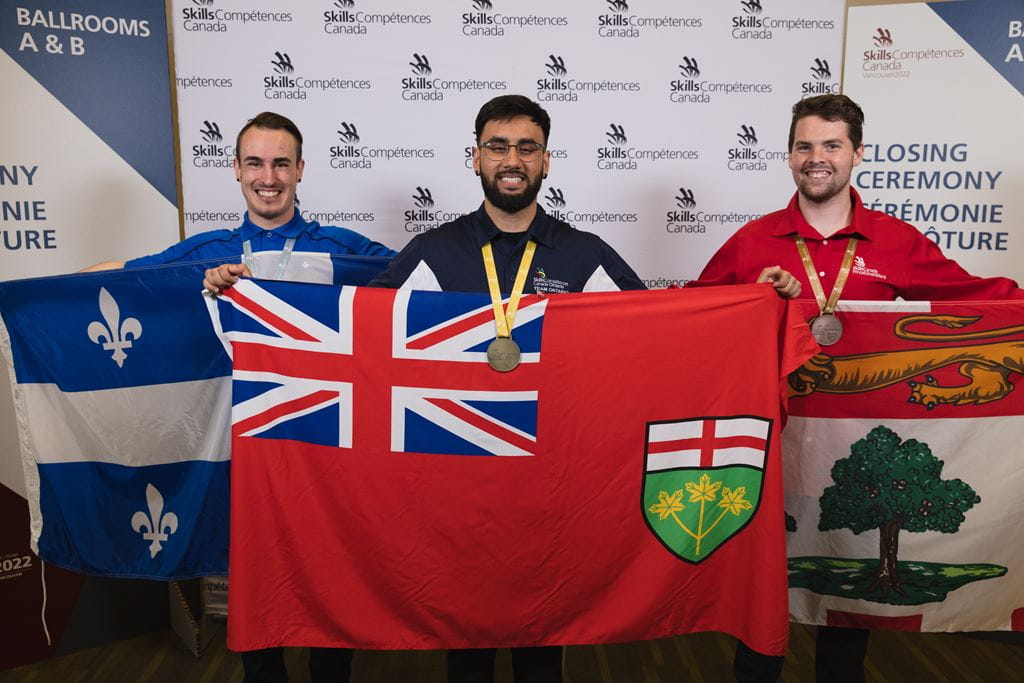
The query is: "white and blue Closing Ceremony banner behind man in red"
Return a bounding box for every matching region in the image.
[843,0,1024,282]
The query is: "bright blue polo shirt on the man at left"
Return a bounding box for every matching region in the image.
[125,210,395,284]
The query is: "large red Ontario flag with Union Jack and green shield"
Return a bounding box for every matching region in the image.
[209,281,816,654]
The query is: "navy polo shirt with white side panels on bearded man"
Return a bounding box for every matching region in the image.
[370,205,645,296]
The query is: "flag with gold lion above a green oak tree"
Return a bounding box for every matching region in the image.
[783,302,1024,631]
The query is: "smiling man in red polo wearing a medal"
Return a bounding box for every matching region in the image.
[696,95,1024,682]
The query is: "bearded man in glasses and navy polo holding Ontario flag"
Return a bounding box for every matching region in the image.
[370,95,644,683]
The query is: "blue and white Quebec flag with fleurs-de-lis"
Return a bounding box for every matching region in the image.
[0,257,386,579]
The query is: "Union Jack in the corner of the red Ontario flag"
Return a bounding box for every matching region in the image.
[209,281,547,456]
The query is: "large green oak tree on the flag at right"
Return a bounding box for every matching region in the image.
[818,426,981,593]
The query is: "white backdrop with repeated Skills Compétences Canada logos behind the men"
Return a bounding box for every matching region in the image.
[172,0,845,287]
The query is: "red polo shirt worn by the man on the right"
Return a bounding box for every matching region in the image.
[696,187,1024,301]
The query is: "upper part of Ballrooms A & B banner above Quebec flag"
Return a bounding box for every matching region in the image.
[0,0,178,280]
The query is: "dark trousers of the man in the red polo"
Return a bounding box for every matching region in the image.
[732,626,871,683]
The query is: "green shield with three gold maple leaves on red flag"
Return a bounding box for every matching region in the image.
[640,416,771,563]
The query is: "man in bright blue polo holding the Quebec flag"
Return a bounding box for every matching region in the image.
[86,112,394,683]
